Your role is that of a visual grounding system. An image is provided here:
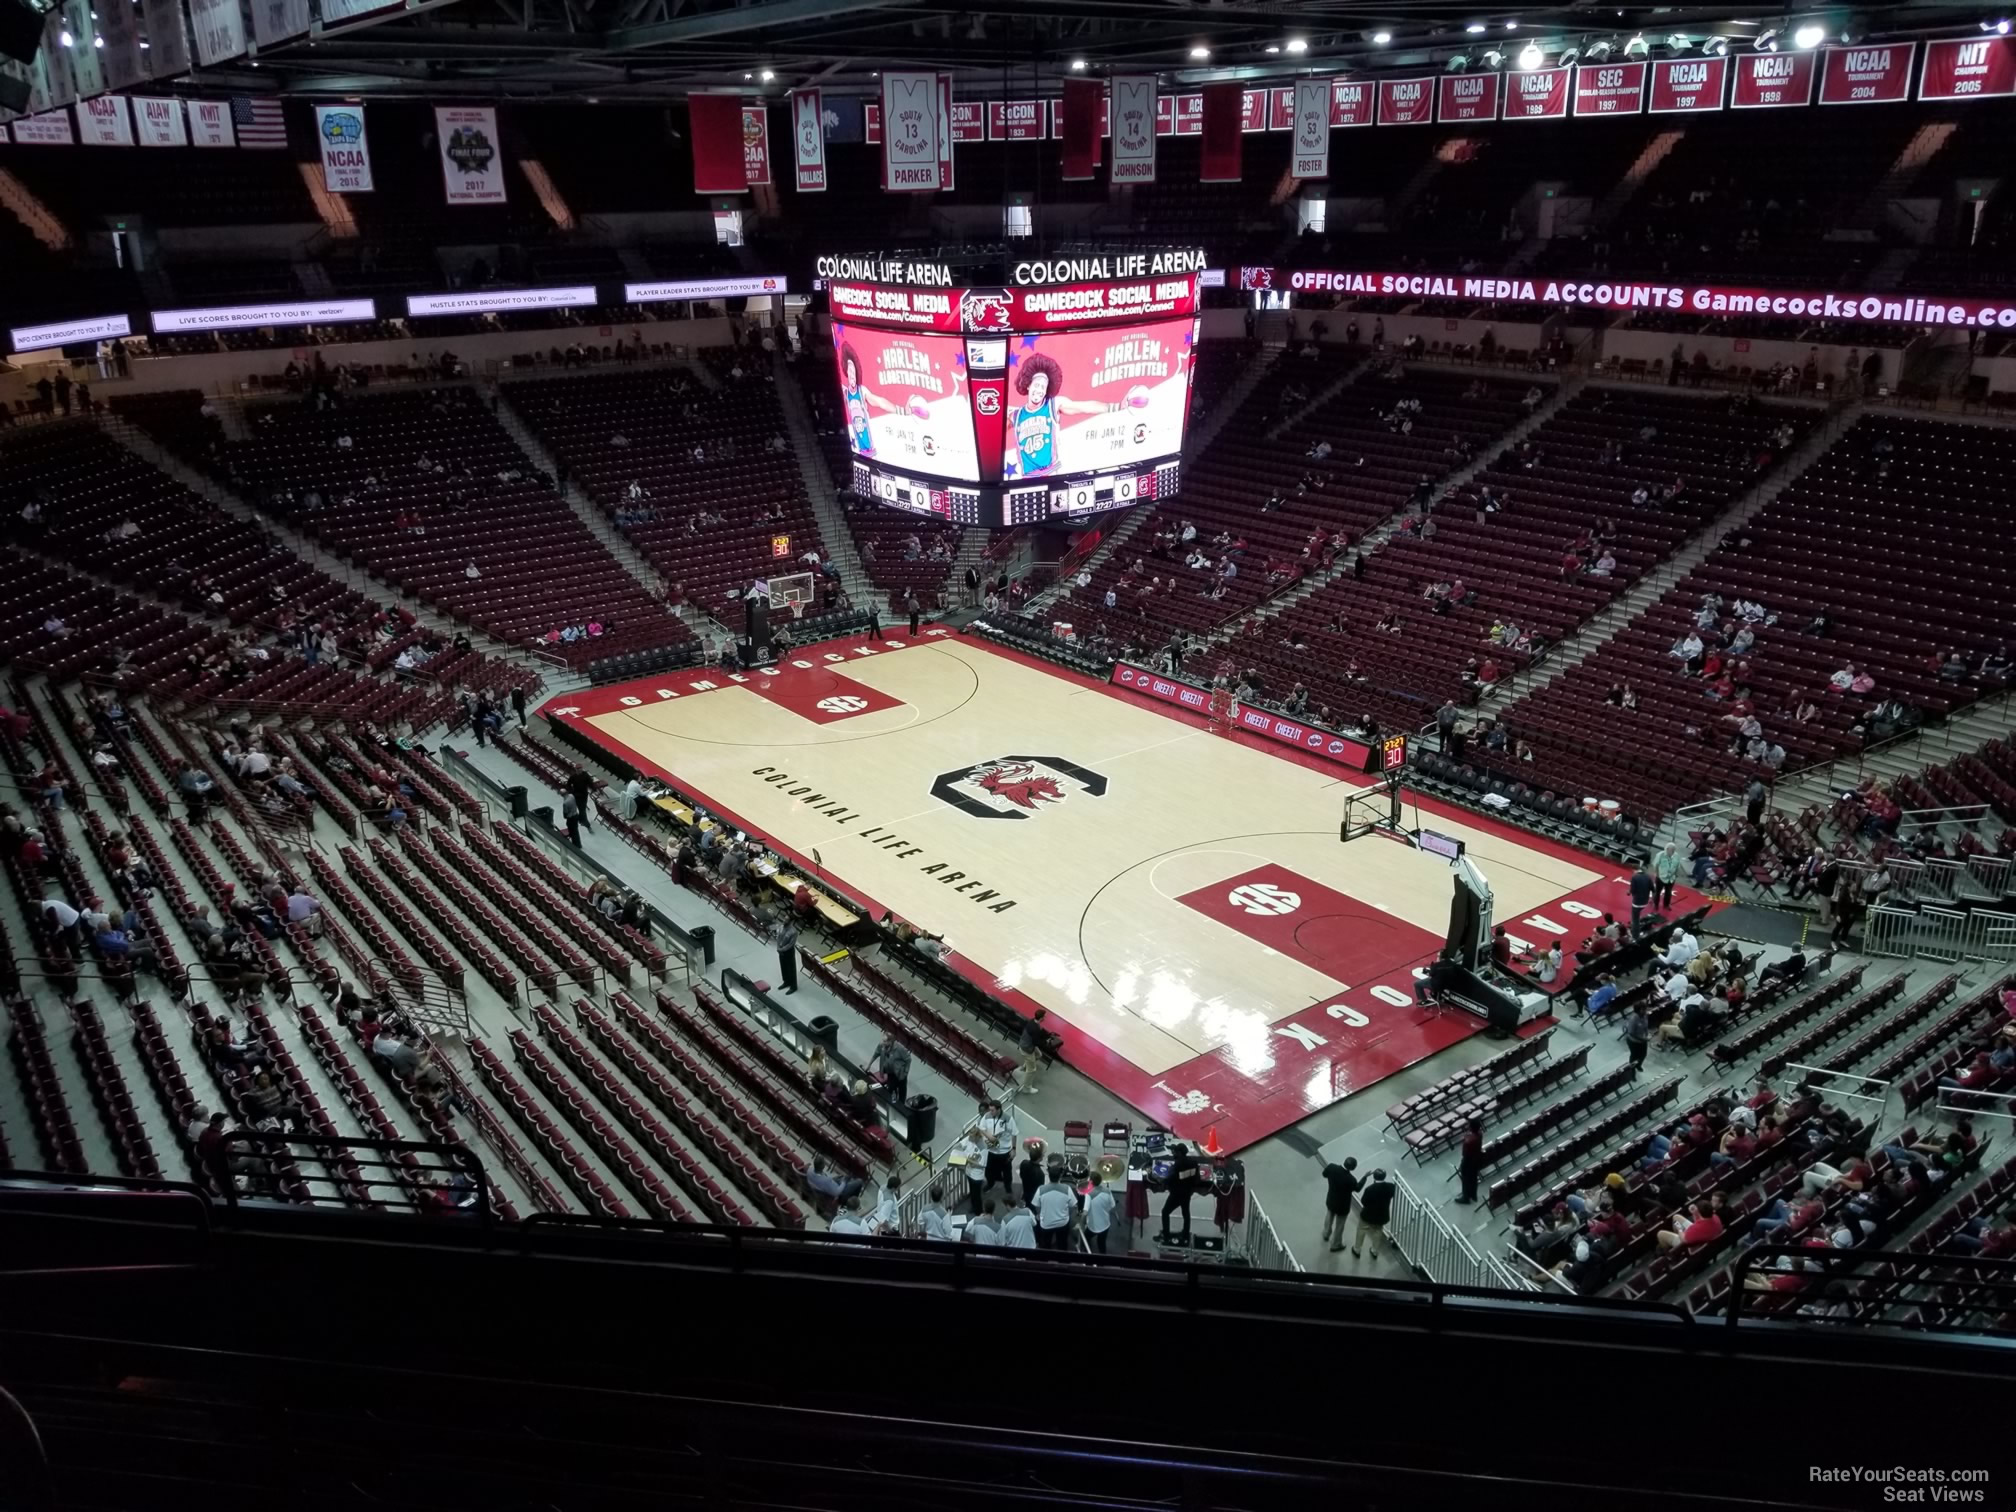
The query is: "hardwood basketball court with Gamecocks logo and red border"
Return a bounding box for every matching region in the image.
[546,627,1691,1149]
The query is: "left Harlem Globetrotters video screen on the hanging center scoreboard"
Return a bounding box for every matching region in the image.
[833,321,980,484]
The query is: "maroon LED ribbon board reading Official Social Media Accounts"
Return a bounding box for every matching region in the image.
[1266,268,2016,331]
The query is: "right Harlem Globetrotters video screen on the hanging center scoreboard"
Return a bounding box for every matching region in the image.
[1002,321,1198,482]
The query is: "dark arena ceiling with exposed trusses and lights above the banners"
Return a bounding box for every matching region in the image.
[134,0,2004,101]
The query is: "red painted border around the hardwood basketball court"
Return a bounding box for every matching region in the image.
[538,627,1710,1151]
